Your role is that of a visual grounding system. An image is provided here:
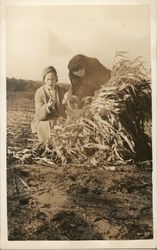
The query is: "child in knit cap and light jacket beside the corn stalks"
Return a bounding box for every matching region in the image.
[31,66,70,143]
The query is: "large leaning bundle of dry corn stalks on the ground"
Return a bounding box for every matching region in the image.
[46,52,151,166]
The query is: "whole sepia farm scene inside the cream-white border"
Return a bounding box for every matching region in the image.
[0,1,155,247]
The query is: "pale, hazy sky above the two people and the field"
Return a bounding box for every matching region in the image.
[6,5,151,82]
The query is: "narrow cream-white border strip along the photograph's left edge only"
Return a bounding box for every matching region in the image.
[0,0,7,248]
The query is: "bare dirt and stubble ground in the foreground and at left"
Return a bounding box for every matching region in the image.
[7,111,153,240]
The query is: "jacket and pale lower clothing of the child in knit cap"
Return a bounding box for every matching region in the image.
[31,84,69,142]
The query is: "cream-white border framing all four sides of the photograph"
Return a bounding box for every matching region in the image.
[0,0,157,249]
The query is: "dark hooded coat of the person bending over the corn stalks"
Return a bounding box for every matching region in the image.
[68,55,111,100]
